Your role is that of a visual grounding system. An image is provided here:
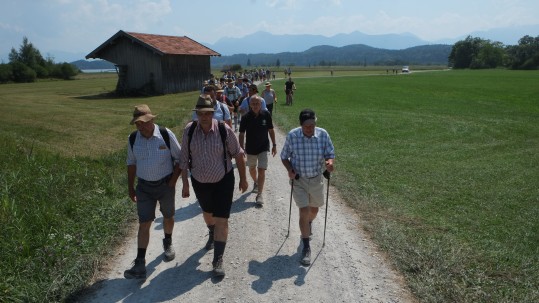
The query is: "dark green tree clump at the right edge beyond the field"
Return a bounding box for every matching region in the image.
[449,35,539,70]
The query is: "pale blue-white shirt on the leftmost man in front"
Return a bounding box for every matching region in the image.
[127,124,181,181]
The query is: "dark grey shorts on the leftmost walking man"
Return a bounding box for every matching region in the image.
[135,176,176,223]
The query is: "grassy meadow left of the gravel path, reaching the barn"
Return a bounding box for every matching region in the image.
[0,75,196,302]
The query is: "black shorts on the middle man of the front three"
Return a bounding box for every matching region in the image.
[191,169,235,219]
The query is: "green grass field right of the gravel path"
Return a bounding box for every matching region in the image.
[276,70,539,302]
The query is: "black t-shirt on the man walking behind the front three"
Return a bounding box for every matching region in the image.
[240,109,273,155]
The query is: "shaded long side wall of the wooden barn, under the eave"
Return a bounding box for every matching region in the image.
[161,55,211,94]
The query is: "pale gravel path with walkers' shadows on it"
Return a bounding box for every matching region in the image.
[81,124,415,303]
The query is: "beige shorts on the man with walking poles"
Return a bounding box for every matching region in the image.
[292,174,324,208]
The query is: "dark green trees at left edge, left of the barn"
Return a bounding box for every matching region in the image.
[0,37,79,83]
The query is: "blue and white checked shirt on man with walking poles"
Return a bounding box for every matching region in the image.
[281,127,335,178]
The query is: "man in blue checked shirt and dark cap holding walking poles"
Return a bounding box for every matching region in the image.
[281,109,335,266]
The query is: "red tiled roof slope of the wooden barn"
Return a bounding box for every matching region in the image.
[126,32,220,56]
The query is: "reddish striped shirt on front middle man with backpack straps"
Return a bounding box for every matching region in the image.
[180,119,244,183]
